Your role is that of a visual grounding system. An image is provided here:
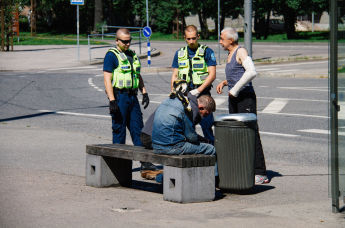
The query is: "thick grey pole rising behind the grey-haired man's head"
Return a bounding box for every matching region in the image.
[244,0,252,56]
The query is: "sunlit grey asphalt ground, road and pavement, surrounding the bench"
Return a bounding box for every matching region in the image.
[0,47,345,228]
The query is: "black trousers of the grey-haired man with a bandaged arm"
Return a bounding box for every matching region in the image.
[229,89,266,175]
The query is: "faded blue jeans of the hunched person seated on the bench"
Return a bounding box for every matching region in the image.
[153,142,218,176]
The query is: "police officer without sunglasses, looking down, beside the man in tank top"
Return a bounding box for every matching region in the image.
[171,25,217,144]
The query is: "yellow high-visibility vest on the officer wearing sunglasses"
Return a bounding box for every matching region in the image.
[109,48,141,89]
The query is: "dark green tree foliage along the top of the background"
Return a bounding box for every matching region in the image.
[10,0,329,39]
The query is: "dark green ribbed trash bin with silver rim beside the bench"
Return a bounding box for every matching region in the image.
[214,113,257,190]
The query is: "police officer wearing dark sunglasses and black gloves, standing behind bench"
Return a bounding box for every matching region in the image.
[103,28,150,170]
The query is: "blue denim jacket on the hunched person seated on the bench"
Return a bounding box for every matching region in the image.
[152,98,199,149]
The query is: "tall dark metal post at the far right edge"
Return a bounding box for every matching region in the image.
[329,0,340,213]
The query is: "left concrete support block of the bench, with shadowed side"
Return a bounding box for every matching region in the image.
[85,154,132,188]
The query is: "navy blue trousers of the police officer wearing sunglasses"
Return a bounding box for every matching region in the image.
[111,92,144,146]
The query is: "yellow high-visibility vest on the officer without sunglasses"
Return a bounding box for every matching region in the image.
[177,45,208,85]
